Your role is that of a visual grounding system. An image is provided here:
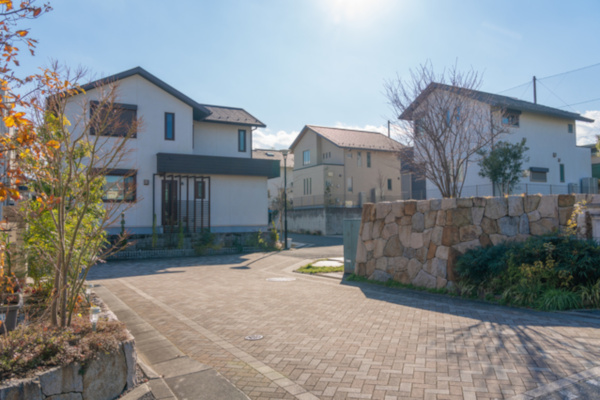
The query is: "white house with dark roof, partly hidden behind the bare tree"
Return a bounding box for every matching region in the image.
[399,83,594,198]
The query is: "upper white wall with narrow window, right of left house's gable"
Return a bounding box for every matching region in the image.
[193,121,252,158]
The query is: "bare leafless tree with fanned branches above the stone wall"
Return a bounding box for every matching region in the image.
[385,63,509,197]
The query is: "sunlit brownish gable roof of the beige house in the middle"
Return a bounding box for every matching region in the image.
[290,125,404,151]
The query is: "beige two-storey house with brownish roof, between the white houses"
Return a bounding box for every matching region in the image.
[290,125,410,209]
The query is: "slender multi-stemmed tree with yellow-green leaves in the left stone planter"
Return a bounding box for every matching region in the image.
[19,65,139,327]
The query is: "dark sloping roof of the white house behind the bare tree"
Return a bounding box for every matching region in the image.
[398,82,594,122]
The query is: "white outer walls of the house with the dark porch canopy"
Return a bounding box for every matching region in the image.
[67,75,268,233]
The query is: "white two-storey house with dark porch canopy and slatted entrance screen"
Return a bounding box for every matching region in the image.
[67,67,279,234]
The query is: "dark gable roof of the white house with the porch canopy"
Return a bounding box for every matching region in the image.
[81,67,266,128]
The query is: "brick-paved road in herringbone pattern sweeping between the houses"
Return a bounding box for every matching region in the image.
[91,249,600,399]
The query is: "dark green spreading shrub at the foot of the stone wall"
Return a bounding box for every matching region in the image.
[456,236,600,310]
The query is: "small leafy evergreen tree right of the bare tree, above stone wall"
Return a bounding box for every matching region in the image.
[478,138,529,194]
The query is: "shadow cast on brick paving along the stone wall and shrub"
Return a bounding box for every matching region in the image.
[341,280,600,382]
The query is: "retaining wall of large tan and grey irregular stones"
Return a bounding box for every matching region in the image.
[355,194,600,288]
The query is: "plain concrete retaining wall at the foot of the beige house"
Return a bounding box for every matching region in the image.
[288,207,362,235]
